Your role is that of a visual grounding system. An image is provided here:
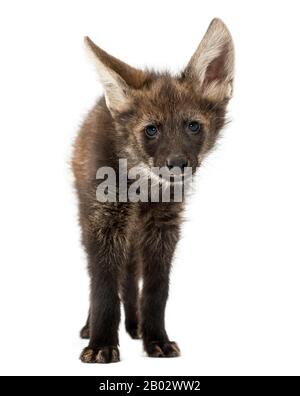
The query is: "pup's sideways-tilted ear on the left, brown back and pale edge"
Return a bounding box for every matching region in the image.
[84,37,147,113]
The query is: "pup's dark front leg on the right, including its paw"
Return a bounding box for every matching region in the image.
[142,206,180,357]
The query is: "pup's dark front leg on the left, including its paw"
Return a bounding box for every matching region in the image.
[80,204,132,363]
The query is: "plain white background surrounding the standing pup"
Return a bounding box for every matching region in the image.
[0,0,300,375]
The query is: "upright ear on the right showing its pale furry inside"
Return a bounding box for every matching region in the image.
[184,19,234,101]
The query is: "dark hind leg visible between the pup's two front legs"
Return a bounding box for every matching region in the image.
[121,247,141,339]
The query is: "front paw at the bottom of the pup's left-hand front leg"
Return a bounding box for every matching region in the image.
[80,346,120,363]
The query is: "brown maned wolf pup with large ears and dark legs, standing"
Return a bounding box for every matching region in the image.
[73,19,234,363]
